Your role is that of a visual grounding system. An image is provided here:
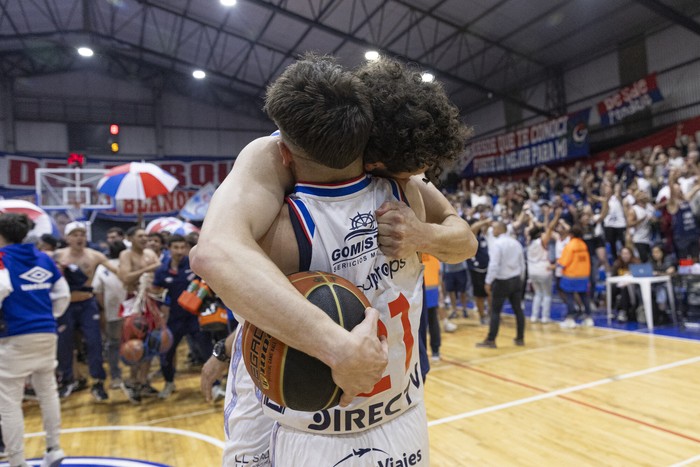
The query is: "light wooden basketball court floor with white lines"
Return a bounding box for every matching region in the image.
[8,315,700,467]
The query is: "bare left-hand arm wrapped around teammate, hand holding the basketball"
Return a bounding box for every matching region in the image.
[190,137,386,395]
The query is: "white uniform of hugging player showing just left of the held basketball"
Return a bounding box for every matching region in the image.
[223,326,275,467]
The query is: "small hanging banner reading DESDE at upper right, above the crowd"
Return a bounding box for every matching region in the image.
[597,73,664,127]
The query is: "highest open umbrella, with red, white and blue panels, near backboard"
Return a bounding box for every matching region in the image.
[97,162,178,200]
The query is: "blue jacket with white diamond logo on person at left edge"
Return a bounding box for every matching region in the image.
[0,244,62,337]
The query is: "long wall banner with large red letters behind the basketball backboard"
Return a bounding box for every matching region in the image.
[0,152,234,221]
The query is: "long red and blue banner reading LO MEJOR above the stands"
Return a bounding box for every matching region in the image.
[462,108,591,177]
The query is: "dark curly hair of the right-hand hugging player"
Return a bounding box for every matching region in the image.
[355,57,471,180]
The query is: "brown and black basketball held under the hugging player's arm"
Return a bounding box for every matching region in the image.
[242,271,370,412]
